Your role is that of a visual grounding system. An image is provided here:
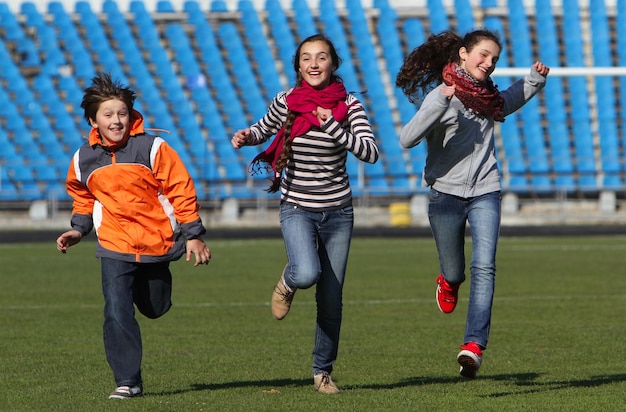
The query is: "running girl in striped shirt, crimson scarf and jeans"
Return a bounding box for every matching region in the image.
[231,34,378,394]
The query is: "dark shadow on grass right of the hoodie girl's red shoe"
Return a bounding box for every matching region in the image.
[481,373,626,398]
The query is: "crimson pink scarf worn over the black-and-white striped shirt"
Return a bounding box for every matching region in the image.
[250,79,348,180]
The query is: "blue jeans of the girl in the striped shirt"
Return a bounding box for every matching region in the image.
[280,204,354,375]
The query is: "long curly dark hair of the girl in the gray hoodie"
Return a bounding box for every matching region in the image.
[396,29,502,102]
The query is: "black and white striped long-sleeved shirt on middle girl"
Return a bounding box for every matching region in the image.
[247,91,378,211]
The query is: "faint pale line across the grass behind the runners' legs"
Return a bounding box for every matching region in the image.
[0,293,626,311]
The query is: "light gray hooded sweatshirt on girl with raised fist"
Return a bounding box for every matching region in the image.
[400,68,546,198]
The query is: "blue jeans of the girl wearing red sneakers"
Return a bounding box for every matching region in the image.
[428,188,501,348]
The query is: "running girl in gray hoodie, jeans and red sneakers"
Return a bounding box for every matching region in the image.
[396,30,550,378]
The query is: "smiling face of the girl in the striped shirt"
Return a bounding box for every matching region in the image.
[298,40,336,89]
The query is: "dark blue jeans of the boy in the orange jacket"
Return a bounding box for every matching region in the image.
[100,258,172,386]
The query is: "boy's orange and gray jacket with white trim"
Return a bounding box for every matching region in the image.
[66,111,206,263]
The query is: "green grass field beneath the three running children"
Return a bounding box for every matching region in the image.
[0,236,626,411]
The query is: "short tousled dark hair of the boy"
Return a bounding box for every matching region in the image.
[80,73,137,124]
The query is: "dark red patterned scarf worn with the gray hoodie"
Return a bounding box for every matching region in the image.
[442,63,504,122]
